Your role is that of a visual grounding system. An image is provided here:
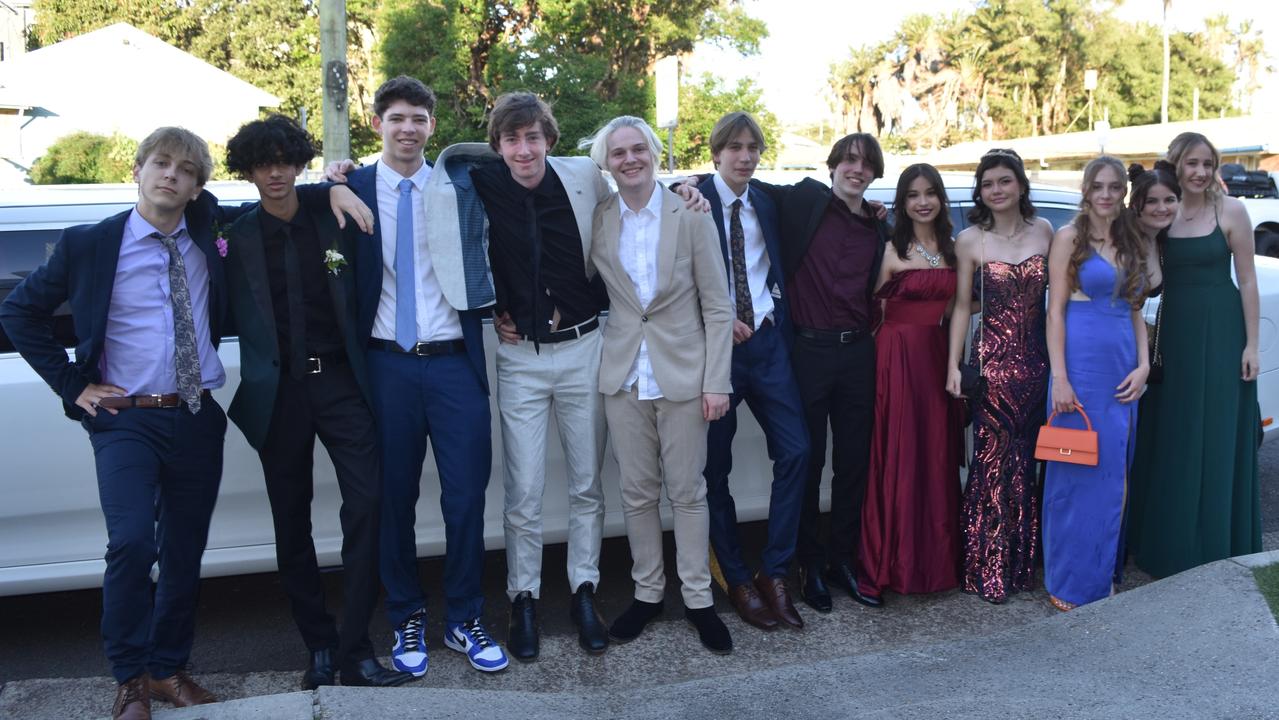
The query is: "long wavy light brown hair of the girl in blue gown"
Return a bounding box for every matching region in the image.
[1067,155,1146,309]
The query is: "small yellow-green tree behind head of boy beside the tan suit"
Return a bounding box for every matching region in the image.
[664,73,781,168]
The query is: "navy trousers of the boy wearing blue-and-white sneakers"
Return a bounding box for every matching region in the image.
[367,349,492,627]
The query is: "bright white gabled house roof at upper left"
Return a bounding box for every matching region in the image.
[0,23,280,107]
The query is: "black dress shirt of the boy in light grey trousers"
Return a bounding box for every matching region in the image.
[471,160,609,339]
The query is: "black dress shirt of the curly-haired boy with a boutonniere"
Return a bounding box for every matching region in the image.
[258,196,343,364]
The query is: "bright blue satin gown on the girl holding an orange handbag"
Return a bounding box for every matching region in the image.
[1044,252,1137,605]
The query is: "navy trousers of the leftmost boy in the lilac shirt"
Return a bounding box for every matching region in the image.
[83,395,226,683]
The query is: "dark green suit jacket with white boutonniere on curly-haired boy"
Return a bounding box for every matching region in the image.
[225,197,371,450]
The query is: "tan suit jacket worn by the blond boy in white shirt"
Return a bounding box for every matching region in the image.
[591,185,733,402]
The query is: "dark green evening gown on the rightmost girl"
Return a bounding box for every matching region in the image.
[1128,226,1261,578]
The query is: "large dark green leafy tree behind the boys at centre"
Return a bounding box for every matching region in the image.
[377,0,766,153]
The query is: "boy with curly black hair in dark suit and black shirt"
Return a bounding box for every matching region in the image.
[226,115,413,689]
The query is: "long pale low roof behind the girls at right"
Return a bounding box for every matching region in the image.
[922,115,1279,169]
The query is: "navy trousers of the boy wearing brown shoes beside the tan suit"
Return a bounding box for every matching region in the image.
[703,324,808,587]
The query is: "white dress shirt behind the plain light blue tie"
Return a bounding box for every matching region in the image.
[373,162,462,343]
